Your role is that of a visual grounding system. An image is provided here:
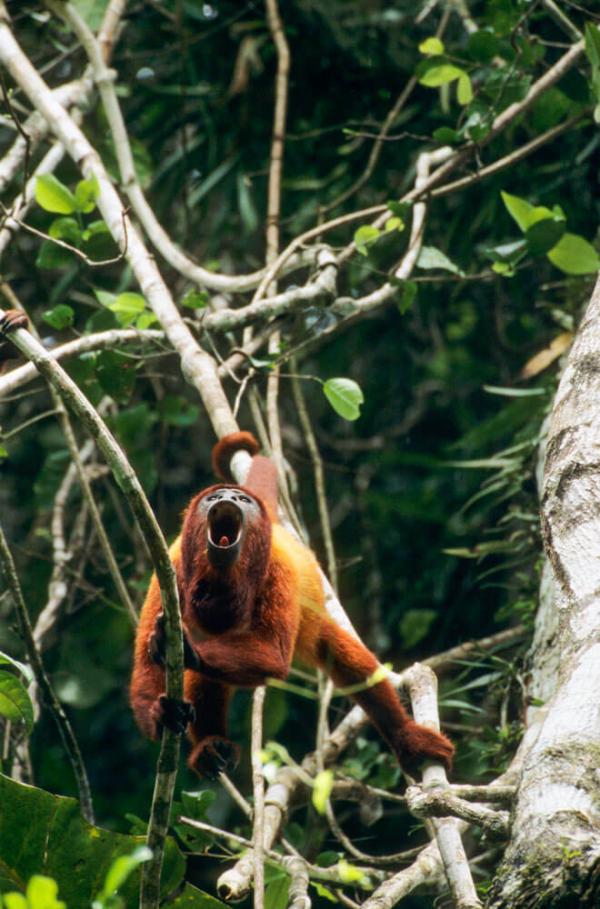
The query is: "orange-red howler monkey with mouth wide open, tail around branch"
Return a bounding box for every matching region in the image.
[130,432,454,778]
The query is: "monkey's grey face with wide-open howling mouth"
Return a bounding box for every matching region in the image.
[197,487,262,569]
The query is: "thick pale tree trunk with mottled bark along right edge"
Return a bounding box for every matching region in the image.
[488,272,600,909]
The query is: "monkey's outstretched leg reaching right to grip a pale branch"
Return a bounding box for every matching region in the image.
[315,618,454,773]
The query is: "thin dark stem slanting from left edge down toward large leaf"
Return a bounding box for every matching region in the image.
[0,526,94,824]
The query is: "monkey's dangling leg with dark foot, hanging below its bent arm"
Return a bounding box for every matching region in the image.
[185,672,240,780]
